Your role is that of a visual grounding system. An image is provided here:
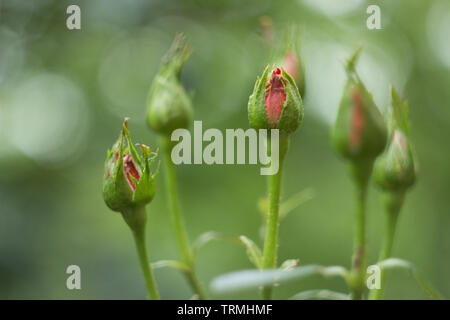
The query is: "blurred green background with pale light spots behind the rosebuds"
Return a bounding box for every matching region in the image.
[0,0,450,299]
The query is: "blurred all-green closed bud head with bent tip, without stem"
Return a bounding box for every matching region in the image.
[147,34,193,135]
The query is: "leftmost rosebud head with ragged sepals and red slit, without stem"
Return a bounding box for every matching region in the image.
[103,118,158,213]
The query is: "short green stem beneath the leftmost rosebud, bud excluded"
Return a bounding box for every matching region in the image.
[122,206,159,300]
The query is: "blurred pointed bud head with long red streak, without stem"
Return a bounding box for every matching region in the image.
[331,50,387,163]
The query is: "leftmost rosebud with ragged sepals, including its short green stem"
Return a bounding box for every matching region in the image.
[103,118,159,300]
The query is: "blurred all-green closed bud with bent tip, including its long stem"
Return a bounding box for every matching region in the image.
[147,34,208,300]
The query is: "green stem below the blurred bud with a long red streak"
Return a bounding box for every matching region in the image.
[349,161,373,300]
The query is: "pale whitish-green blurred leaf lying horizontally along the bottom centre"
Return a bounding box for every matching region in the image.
[211,265,348,293]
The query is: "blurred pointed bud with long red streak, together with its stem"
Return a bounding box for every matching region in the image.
[331,50,387,299]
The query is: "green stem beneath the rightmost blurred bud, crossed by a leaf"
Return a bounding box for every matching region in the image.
[369,191,404,300]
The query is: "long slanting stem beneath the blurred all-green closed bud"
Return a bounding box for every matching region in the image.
[160,136,207,300]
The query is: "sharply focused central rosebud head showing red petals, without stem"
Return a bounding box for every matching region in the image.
[248,66,303,134]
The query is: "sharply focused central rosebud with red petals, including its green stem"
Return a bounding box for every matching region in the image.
[248,66,303,299]
